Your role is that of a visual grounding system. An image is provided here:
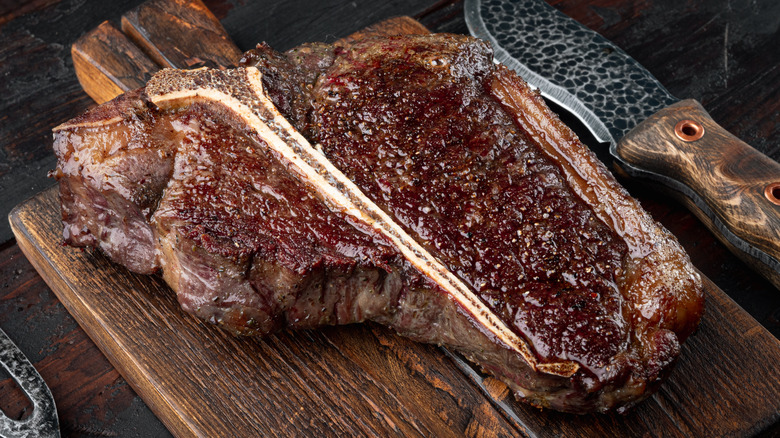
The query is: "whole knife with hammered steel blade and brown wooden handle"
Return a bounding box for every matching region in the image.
[465,0,780,288]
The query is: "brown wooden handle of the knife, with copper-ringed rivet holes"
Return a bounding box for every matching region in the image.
[617,100,780,288]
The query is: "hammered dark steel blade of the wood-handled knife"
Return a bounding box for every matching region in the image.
[465,0,678,145]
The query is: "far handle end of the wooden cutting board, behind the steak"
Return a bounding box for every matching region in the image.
[71,0,430,103]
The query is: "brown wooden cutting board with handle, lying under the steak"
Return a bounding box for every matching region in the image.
[9,0,780,437]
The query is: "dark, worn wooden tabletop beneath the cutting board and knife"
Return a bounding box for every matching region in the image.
[0,0,780,437]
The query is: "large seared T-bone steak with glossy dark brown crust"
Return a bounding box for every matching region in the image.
[55,35,702,412]
